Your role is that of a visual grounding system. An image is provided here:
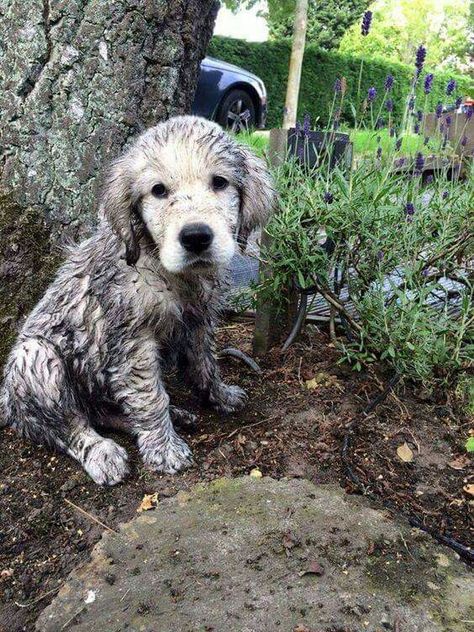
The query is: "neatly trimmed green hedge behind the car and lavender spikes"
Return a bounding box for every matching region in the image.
[208,37,474,127]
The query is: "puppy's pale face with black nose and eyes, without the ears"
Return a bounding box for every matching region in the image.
[139,133,243,273]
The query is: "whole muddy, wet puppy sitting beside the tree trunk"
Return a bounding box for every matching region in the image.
[2,116,275,485]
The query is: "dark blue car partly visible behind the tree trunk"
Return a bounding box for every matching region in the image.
[192,57,267,132]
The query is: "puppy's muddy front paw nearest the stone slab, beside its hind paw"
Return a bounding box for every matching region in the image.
[138,431,193,474]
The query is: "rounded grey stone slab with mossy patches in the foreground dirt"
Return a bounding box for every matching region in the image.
[36,477,474,632]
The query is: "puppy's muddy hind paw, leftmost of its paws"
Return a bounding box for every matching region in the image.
[82,439,129,485]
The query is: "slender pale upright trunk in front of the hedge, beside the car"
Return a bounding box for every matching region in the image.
[283,0,308,129]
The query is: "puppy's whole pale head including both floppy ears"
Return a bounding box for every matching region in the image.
[103,116,274,274]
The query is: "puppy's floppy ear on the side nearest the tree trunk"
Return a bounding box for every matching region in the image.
[101,157,140,265]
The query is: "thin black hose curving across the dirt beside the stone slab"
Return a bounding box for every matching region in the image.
[341,373,474,564]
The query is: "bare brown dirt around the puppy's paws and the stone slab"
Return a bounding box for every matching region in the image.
[0,322,474,632]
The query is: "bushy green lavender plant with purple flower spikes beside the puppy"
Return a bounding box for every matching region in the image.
[257,34,474,386]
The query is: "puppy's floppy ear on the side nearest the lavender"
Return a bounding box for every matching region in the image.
[238,147,276,249]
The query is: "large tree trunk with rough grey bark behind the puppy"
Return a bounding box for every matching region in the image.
[0,0,218,362]
